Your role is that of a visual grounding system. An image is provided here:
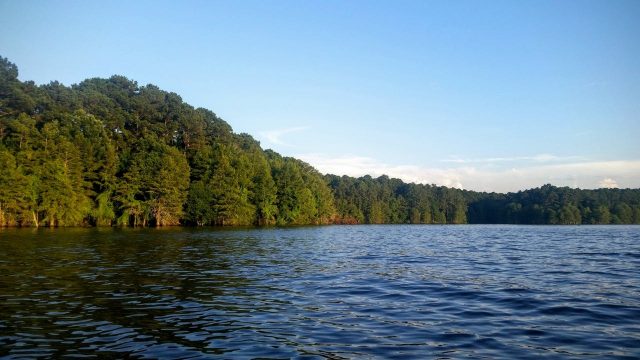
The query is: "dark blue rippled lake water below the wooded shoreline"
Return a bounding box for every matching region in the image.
[0,226,640,359]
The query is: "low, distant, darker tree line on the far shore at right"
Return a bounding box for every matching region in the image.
[327,175,640,225]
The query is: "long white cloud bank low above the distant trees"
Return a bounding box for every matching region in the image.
[297,154,640,192]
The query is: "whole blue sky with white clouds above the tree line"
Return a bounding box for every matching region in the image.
[0,0,640,192]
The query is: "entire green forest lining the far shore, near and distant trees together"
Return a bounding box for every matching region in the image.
[0,57,640,227]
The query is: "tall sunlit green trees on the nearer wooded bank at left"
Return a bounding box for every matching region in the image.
[0,58,335,226]
